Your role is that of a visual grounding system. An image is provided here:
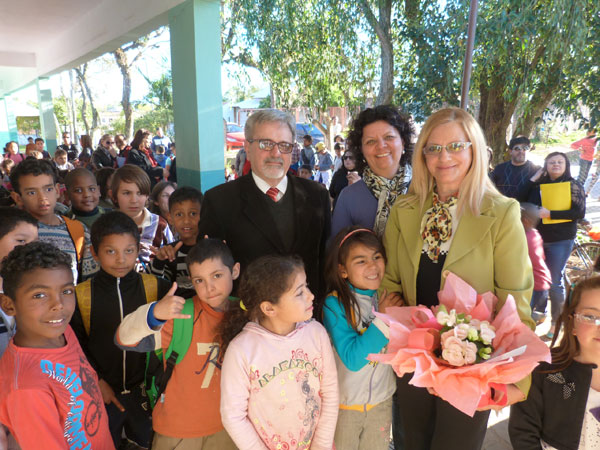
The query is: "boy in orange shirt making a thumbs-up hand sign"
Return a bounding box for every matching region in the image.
[116,239,240,450]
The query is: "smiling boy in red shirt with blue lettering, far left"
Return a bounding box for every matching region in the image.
[0,242,115,450]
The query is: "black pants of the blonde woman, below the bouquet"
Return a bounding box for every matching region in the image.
[394,374,490,450]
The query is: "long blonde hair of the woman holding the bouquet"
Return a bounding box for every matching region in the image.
[407,107,501,216]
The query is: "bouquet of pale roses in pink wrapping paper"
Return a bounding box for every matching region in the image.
[369,273,550,417]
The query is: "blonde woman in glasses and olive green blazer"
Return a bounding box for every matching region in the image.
[381,108,535,450]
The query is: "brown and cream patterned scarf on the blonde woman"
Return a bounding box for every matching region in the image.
[421,192,458,263]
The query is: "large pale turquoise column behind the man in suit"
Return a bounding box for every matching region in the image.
[169,0,225,192]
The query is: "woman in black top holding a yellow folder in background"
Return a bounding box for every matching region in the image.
[529,152,585,338]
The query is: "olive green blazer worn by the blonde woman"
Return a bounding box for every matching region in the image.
[380,190,535,329]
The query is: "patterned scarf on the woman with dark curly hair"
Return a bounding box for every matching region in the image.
[363,165,412,236]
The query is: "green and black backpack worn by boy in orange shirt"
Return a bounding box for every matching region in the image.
[145,298,194,409]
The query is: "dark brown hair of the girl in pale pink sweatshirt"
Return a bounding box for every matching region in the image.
[218,255,304,354]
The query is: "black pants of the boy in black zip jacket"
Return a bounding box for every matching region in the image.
[106,386,152,448]
